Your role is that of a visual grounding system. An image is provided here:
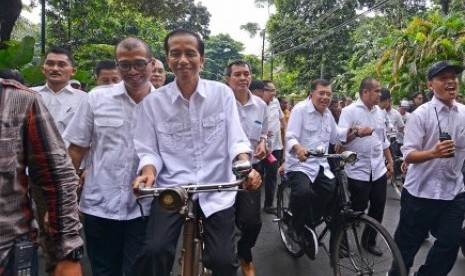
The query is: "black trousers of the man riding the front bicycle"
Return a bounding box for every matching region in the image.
[134,200,237,276]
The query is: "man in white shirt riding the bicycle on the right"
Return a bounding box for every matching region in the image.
[285,79,371,256]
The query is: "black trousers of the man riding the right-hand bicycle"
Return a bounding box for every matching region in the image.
[287,167,336,233]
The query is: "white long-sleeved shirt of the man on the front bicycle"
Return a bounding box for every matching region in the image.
[134,79,252,217]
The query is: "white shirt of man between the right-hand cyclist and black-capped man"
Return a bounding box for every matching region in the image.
[339,99,389,181]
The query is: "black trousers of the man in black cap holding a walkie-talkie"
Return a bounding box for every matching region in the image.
[390,189,465,276]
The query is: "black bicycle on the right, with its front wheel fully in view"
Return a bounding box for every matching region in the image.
[275,151,407,276]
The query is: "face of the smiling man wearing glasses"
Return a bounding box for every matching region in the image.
[116,45,155,90]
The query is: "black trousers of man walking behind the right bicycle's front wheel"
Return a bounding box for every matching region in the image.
[347,174,387,245]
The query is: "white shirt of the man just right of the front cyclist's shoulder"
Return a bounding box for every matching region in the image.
[236,91,268,164]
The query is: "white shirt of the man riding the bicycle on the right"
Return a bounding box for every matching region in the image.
[284,98,347,183]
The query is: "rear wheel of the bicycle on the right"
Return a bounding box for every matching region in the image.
[277,181,305,258]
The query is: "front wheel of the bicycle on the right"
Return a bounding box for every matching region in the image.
[330,214,407,276]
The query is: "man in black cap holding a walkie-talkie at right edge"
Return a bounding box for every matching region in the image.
[390,61,465,275]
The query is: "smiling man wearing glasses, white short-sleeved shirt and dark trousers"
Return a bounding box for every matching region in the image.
[64,37,155,275]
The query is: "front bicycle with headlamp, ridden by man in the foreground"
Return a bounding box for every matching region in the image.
[138,160,252,276]
